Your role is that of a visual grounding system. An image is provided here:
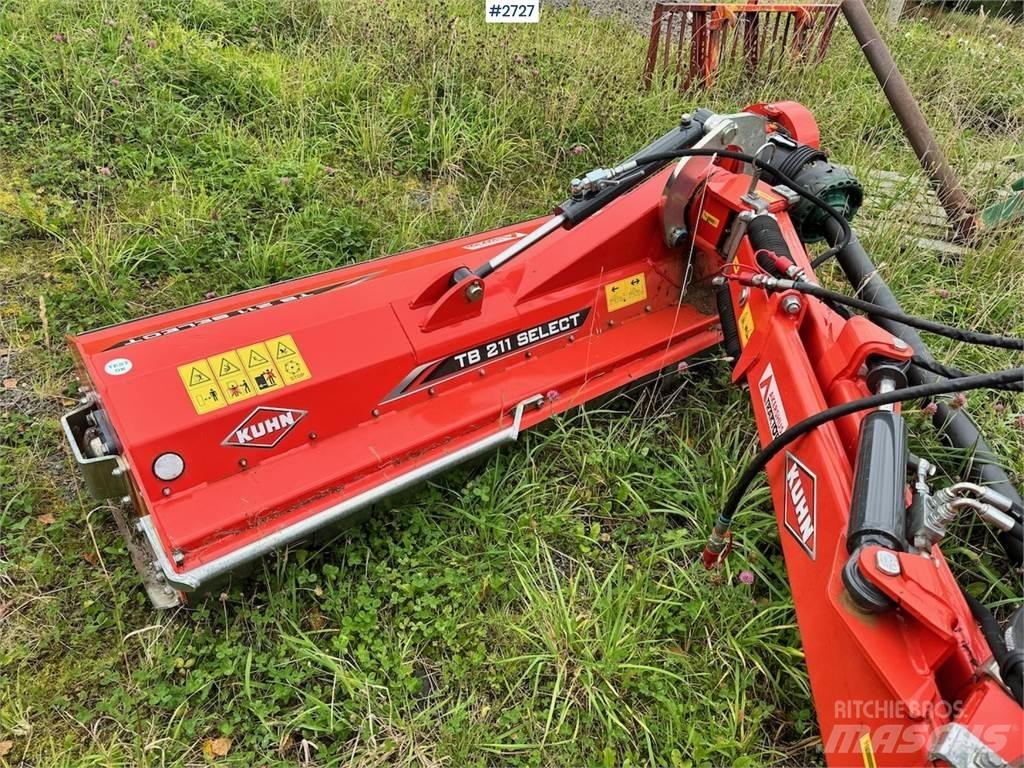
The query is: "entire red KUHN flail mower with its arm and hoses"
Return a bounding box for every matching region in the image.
[63,102,1024,768]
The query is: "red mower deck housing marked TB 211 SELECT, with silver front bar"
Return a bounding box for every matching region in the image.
[69,170,720,606]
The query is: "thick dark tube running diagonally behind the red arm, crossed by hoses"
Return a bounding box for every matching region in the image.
[824,221,1024,565]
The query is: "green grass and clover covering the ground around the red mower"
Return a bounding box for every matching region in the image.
[0,0,1024,766]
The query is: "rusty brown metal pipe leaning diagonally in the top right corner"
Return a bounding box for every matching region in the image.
[843,0,979,242]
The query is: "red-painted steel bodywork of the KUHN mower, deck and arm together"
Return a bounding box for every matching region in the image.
[66,103,1024,766]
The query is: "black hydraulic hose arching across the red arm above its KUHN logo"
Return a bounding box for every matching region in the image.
[715,368,1024,536]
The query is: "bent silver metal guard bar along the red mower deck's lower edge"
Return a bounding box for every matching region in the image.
[142,395,544,592]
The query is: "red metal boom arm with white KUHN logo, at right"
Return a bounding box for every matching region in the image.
[690,148,1024,766]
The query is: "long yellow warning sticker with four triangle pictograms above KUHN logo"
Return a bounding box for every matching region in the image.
[178,335,312,415]
